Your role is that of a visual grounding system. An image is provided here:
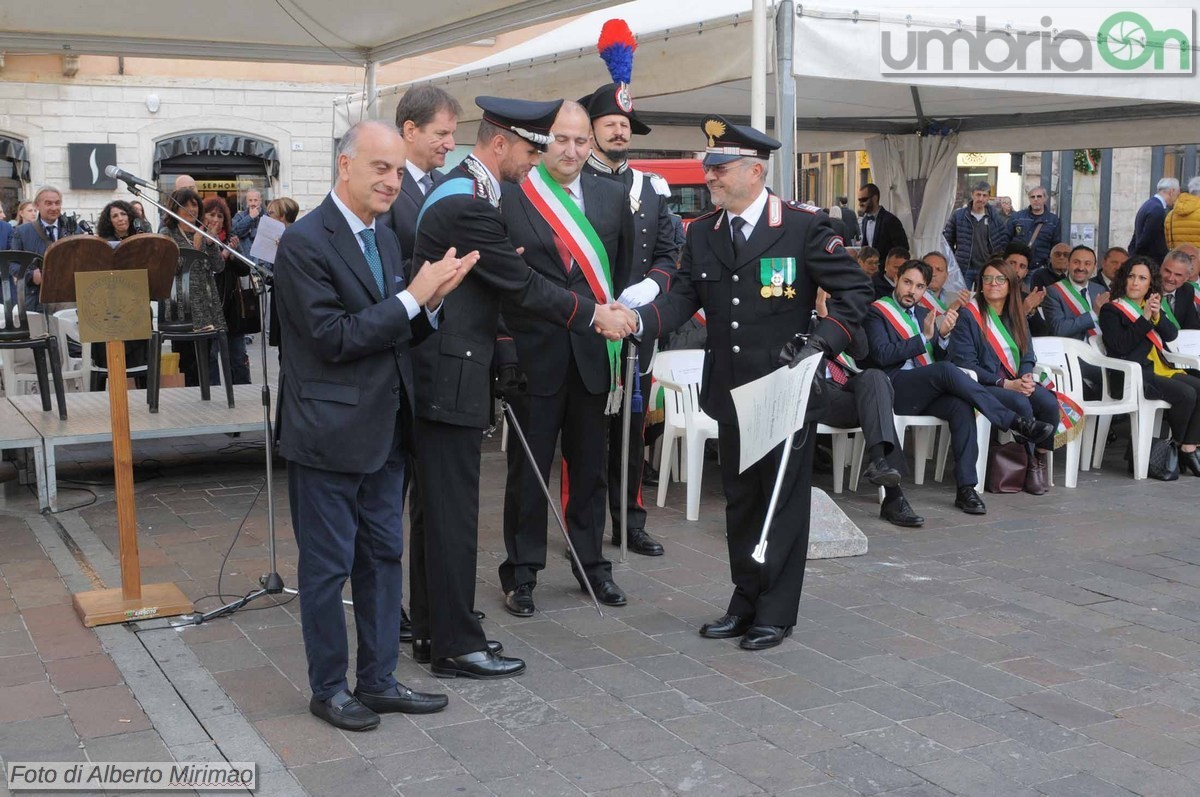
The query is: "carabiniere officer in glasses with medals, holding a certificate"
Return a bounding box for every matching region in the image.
[636,115,872,651]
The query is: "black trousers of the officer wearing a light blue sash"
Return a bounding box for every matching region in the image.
[412,418,487,658]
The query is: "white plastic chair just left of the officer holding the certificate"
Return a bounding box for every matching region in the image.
[654,349,718,520]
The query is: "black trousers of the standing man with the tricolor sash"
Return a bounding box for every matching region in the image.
[499,364,612,592]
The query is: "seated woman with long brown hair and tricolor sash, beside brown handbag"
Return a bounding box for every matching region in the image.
[950,258,1058,496]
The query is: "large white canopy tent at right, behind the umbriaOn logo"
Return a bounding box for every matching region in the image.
[335,0,1200,258]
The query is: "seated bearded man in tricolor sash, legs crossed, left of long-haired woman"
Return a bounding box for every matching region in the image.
[864,260,1054,515]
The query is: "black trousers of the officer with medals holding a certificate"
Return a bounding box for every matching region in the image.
[718,424,816,625]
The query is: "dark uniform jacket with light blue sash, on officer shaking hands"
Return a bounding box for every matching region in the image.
[413,157,595,429]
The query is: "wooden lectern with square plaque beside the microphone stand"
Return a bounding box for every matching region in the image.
[42,235,192,627]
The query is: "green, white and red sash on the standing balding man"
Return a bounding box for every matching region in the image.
[521,163,622,415]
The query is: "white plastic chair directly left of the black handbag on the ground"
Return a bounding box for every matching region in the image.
[1080,335,1170,479]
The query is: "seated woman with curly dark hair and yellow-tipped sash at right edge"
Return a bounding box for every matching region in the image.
[1099,256,1200,477]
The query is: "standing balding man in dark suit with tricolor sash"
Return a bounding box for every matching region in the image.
[499,100,632,617]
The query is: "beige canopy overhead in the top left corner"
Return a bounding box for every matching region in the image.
[0,0,613,66]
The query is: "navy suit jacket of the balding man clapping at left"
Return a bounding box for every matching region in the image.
[275,197,434,473]
